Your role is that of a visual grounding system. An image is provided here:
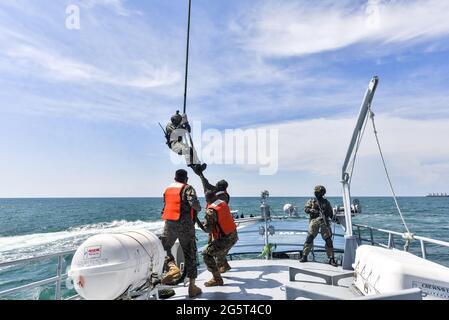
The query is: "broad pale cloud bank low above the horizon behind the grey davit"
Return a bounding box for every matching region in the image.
[180,113,449,195]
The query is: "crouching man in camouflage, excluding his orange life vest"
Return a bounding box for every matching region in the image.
[203,191,238,287]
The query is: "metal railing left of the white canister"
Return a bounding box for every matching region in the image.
[0,250,77,300]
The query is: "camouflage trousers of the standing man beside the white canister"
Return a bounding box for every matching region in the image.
[161,215,198,279]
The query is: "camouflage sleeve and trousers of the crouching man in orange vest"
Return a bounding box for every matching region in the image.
[203,208,239,274]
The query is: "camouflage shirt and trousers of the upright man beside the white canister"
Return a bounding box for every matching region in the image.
[161,186,201,279]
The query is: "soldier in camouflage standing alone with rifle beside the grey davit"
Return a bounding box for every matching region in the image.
[300,186,337,266]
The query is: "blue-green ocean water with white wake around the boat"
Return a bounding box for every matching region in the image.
[0,197,449,299]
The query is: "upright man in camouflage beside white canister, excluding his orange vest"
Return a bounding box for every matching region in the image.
[161,169,201,297]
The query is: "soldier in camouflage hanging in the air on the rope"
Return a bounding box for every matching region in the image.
[165,111,207,173]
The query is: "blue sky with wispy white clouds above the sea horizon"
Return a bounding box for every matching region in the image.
[0,0,449,197]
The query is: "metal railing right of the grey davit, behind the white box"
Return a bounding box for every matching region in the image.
[353,224,449,259]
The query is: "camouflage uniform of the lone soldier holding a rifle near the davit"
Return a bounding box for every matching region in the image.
[303,198,334,258]
